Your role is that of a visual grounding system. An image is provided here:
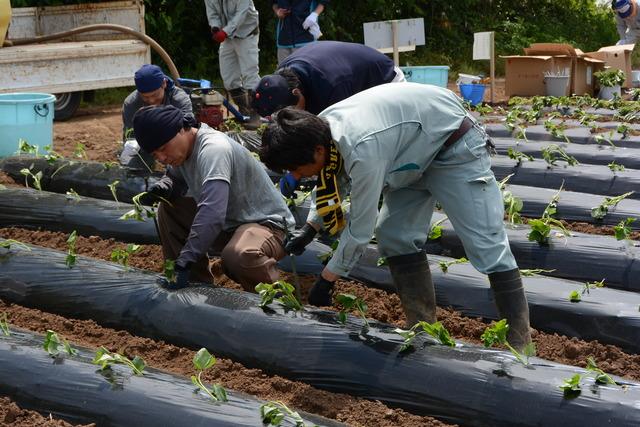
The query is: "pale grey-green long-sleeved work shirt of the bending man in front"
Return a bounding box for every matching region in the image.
[308,83,467,275]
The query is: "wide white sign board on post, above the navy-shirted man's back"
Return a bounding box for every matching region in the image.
[363,18,424,53]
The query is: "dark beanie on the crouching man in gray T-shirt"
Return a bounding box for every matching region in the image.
[133,105,185,153]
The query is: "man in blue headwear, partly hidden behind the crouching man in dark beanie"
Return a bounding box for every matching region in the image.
[120,64,193,169]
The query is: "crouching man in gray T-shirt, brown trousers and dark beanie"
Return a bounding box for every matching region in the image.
[133,106,294,291]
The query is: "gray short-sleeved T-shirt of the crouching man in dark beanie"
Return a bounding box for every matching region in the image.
[173,123,295,231]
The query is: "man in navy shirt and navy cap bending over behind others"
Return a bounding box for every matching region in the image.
[253,41,406,196]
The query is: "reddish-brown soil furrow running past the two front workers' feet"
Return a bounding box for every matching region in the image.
[0,228,640,384]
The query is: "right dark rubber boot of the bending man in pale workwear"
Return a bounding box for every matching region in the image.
[489,268,531,351]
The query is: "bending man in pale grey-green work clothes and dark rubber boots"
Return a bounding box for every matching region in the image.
[261,83,531,348]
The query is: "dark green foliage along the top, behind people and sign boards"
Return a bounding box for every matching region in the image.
[11,0,618,81]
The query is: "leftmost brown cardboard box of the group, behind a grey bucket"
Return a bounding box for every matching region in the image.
[501,55,573,97]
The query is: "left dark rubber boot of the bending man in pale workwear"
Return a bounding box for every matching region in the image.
[387,251,436,328]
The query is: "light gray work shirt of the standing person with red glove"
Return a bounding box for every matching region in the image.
[204,0,258,39]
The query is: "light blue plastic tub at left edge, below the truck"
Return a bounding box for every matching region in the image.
[0,93,56,157]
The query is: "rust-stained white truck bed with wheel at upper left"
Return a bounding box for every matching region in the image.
[0,0,151,120]
